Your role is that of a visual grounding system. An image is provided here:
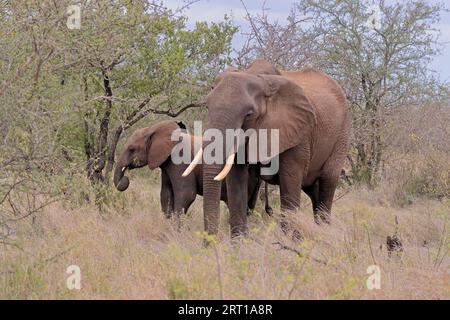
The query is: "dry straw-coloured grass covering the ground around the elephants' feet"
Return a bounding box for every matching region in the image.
[0,179,450,299]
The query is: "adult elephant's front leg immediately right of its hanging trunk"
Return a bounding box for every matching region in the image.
[226,164,248,238]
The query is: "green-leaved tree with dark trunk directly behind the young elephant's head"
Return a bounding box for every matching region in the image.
[57,0,236,182]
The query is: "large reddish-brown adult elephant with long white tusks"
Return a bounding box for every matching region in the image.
[182,60,350,237]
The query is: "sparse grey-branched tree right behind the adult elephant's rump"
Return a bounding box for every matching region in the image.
[236,0,443,186]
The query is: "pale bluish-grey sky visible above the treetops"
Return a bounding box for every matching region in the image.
[163,0,450,81]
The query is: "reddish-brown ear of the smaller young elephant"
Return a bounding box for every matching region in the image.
[147,121,180,170]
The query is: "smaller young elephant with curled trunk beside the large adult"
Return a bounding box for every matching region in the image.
[114,121,271,217]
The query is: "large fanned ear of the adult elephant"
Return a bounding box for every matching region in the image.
[255,75,316,161]
